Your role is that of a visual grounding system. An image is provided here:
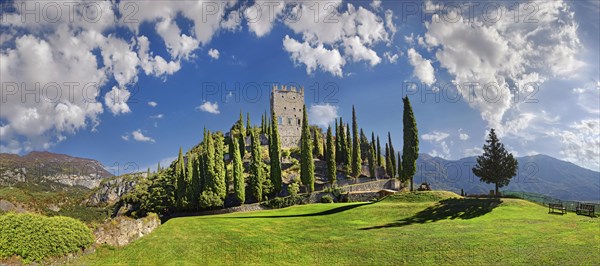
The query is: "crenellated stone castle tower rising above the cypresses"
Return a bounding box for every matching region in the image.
[271,85,304,148]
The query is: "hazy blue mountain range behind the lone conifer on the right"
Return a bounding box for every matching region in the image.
[414,154,600,201]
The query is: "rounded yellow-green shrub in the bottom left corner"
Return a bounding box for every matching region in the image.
[0,213,94,263]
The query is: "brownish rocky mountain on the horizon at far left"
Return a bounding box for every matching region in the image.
[0,151,113,189]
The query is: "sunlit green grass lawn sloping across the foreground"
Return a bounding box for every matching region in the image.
[74,192,600,265]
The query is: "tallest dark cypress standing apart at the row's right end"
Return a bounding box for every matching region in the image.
[402,96,419,191]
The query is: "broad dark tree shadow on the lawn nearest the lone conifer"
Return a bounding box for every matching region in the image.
[360,198,502,230]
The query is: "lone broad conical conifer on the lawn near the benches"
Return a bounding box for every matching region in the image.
[472,128,519,197]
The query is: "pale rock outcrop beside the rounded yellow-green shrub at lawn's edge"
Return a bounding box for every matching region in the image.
[94,213,160,247]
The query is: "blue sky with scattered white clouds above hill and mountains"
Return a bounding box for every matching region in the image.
[0,1,600,173]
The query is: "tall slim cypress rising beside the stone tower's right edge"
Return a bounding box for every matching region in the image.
[300,105,315,192]
